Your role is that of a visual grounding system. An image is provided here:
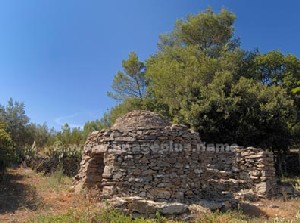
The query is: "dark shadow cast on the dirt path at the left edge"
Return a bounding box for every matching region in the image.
[0,169,42,214]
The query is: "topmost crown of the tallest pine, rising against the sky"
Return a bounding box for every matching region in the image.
[158,8,239,53]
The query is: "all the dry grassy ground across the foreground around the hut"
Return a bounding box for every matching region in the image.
[0,168,300,223]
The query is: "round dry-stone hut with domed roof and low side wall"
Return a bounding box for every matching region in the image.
[75,111,275,203]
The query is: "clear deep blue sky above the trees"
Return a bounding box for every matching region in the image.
[0,0,300,129]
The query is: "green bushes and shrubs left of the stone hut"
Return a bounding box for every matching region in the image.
[0,99,110,172]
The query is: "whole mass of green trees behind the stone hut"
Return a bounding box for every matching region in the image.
[108,9,300,152]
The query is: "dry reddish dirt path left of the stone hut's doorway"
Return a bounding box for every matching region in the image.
[0,168,89,222]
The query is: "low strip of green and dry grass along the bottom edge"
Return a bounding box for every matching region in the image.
[27,205,300,223]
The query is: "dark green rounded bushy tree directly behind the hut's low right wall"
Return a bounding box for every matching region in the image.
[205,77,295,150]
